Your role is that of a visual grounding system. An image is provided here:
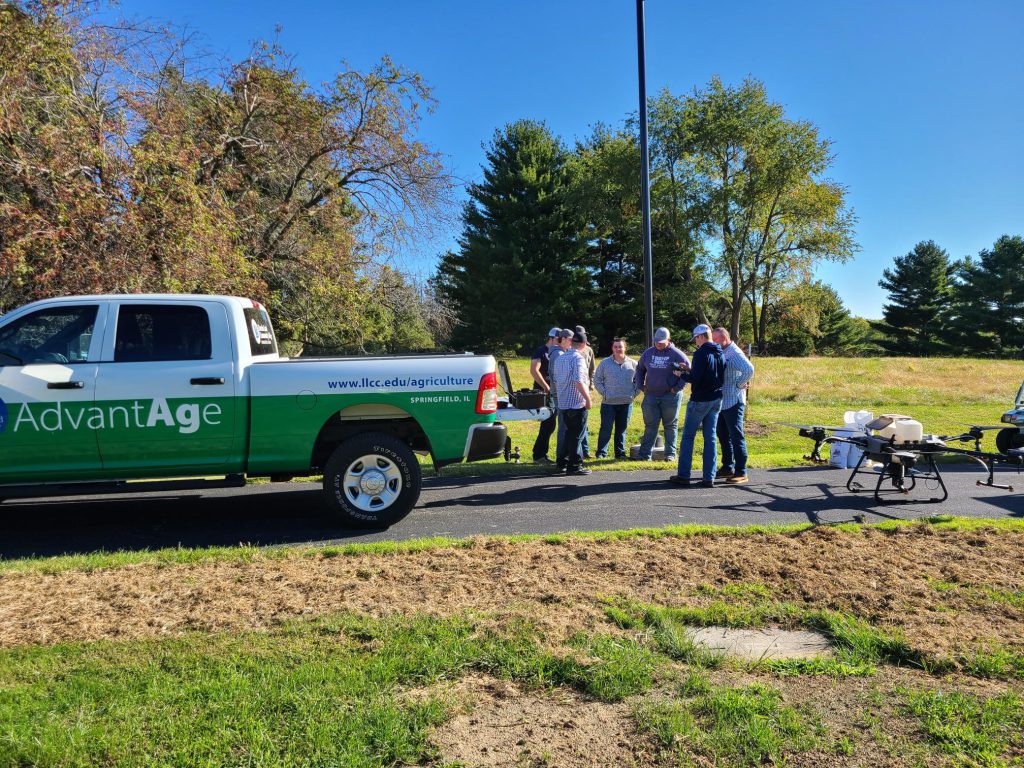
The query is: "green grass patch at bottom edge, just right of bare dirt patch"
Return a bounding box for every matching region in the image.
[635,675,824,768]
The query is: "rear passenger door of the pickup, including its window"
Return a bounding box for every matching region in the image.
[96,300,236,476]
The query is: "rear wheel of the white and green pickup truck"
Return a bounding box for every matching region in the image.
[324,432,423,527]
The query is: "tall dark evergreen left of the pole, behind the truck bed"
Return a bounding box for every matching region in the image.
[437,120,589,350]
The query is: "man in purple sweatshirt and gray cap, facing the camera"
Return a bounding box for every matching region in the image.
[636,328,689,462]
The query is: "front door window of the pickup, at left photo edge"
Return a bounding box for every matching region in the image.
[0,304,97,366]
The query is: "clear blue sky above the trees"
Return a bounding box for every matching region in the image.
[108,0,1024,317]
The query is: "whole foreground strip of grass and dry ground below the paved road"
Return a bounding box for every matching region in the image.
[0,519,1024,768]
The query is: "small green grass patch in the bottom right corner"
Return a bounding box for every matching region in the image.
[899,690,1024,768]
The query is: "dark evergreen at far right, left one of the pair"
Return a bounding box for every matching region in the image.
[878,240,954,356]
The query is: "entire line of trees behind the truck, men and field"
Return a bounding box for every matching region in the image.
[6,0,1024,356]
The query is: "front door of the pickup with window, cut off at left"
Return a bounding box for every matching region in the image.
[0,304,105,483]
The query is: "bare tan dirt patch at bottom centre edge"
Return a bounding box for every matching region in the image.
[431,676,651,768]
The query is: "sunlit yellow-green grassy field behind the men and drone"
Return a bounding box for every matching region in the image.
[452,357,1024,474]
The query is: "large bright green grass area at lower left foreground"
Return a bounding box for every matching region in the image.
[0,615,658,768]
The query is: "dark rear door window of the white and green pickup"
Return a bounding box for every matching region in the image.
[114,304,213,362]
